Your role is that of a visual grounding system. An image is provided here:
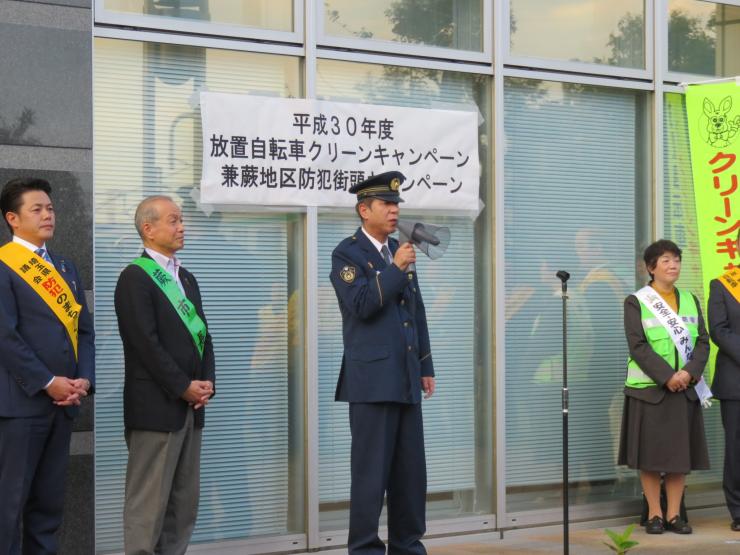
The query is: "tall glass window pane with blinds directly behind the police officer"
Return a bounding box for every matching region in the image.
[317,60,494,530]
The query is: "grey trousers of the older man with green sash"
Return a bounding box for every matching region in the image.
[123,410,203,555]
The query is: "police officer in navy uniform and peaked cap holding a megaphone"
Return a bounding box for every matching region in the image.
[330,172,435,555]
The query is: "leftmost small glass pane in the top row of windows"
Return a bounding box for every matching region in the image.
[104,0,294,31]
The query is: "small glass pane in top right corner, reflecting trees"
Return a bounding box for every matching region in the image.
[668,0,740,77]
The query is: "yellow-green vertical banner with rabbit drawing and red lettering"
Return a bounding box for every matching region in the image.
[686,78,740,380]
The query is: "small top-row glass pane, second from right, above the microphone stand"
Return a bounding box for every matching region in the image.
[509,0,645,69]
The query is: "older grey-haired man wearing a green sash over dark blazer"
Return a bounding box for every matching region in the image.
[115,196,215,555]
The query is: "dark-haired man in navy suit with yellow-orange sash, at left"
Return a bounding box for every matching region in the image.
[0,178,95,555]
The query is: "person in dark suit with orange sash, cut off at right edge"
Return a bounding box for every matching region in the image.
[707,228,740,532]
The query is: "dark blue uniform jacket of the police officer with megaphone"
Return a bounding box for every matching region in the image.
[329,229,434,403]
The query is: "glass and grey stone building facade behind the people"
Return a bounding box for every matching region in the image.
[0,0,740,553]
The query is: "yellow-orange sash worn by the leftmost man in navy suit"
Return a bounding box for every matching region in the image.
[0,241,82,360]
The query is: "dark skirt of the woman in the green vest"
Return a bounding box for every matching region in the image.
[618,391,709,474]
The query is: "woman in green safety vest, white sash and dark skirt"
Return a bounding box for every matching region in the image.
[618,239,709,534]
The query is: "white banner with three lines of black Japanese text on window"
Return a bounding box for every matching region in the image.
[200,92,480,211]
